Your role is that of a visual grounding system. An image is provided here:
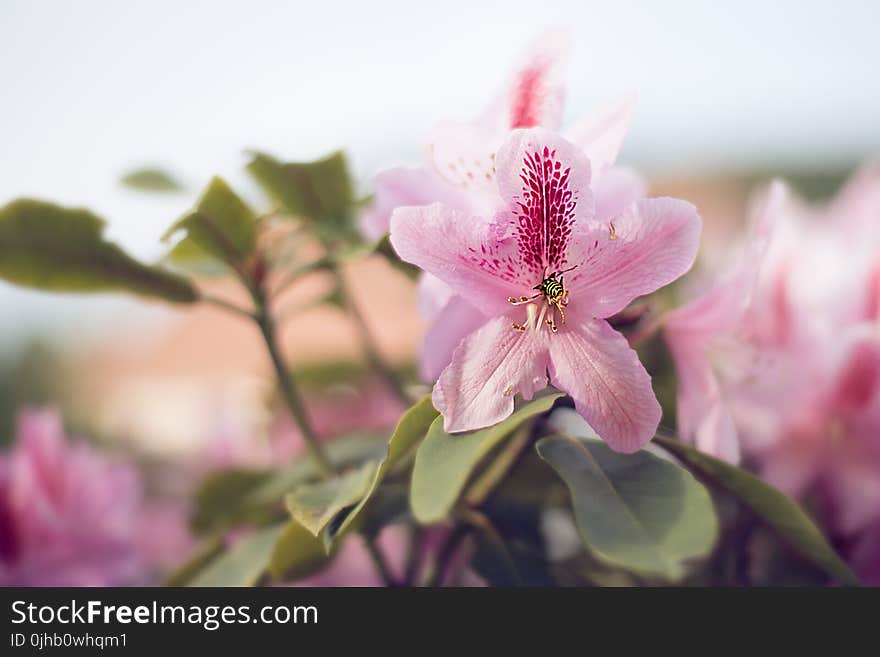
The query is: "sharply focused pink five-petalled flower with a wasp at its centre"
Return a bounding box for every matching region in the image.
[391,128,700,452]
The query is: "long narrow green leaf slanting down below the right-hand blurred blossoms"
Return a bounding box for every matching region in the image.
[654,436,860,586]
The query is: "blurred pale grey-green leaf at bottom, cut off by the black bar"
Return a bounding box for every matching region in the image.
[192,522,288,586]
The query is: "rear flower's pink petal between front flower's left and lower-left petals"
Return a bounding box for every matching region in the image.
[419,296,487,381]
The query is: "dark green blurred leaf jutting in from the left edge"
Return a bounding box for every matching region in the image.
[0,199,198,303]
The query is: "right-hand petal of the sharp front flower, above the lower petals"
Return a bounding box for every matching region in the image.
[568,198,701,317]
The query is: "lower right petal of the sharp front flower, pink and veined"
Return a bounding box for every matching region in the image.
[547,317,661,453]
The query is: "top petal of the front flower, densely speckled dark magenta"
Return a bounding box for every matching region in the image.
[497,128,594,285]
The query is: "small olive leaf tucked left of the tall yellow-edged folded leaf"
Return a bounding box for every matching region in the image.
[285,461,379,536]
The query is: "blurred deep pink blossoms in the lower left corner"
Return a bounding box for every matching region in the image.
[0,410,188,586]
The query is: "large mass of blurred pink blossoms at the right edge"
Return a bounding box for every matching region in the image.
[666,167,880,536]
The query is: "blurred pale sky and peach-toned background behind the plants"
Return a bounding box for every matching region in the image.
[0,0,880,455]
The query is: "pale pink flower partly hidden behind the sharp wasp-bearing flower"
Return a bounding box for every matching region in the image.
[362,32,645,381]
